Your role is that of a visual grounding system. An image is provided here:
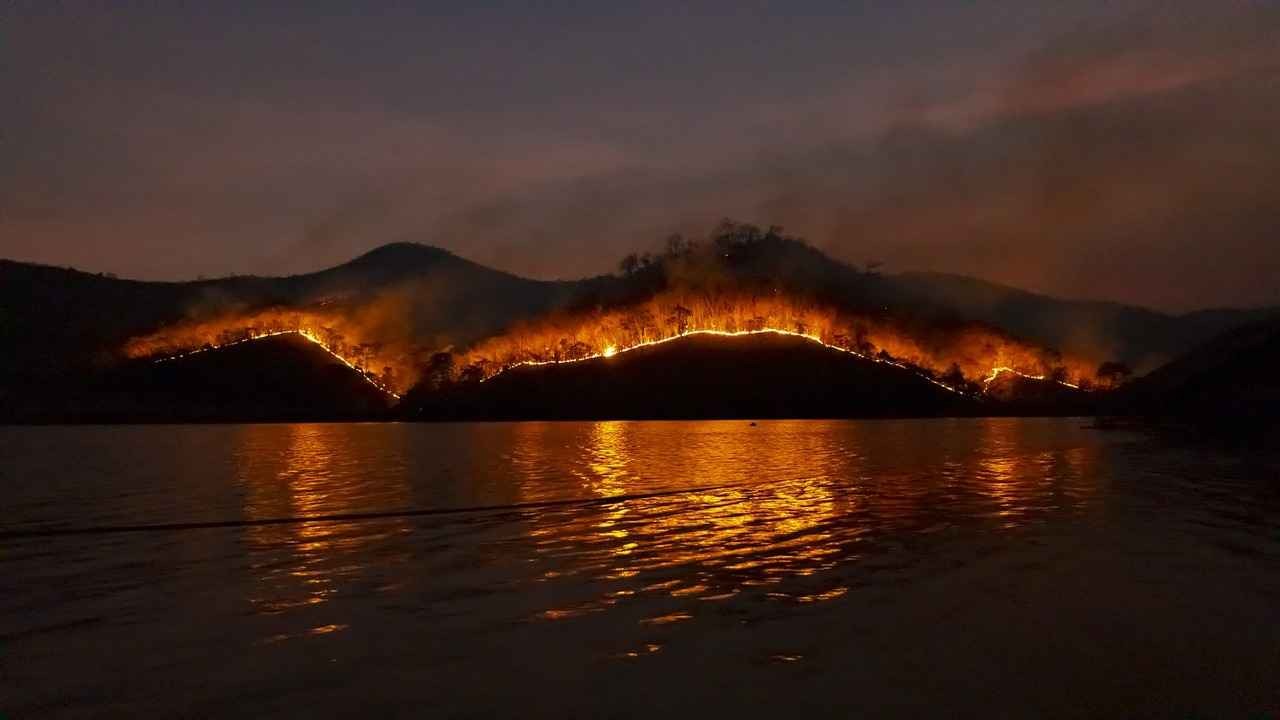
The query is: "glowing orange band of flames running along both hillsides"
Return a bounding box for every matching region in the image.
[124,291,1098,398]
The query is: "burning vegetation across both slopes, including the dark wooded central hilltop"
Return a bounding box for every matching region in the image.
[124,222,1128,397]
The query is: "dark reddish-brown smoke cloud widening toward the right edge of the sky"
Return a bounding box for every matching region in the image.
[419,3,1280,310]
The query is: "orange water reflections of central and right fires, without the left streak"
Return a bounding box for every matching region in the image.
[517,420,1092,619]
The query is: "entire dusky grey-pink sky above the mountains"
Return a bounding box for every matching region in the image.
[0,0,1280,311]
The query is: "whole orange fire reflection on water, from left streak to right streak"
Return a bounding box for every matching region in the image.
[222,420,1098,637]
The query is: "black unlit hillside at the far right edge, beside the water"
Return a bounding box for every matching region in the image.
[1117,316,1280,425]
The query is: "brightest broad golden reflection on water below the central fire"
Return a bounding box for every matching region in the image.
[518,421,850,623]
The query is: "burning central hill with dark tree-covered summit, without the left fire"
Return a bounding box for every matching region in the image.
[425,223,1124,395]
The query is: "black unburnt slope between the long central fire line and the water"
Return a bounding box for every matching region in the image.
[402,334,984,420]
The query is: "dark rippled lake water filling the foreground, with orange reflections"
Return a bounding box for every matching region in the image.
[0,420,1280,717]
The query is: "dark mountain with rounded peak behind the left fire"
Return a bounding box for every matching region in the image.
[0,243,575,398]
